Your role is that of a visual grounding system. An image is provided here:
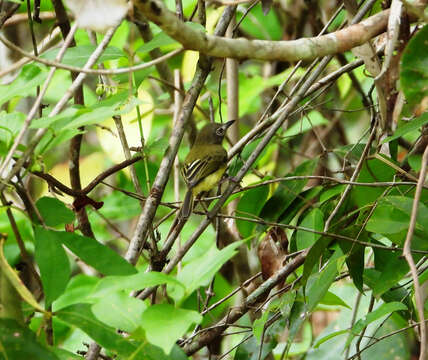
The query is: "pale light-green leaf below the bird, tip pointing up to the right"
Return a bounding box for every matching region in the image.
[174,241,242,301]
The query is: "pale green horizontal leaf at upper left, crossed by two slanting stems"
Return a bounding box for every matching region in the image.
[41,44,126,67]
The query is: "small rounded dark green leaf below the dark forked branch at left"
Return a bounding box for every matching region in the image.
[36,196,74,226]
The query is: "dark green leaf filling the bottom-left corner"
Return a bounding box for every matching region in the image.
[0,319,58,360]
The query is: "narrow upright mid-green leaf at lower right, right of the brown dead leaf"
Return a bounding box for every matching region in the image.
[306,248,345,311]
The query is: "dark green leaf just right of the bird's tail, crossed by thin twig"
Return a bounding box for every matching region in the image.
[236,186,269,238]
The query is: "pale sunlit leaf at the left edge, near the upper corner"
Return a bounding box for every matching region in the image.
[0,64,47,105]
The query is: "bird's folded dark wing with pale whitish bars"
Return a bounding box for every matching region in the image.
[181,151,227,188]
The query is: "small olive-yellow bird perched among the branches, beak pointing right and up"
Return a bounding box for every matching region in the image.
[181,120,235,219]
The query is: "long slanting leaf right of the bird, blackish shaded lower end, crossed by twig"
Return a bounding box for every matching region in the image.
[260,159,318,221]
